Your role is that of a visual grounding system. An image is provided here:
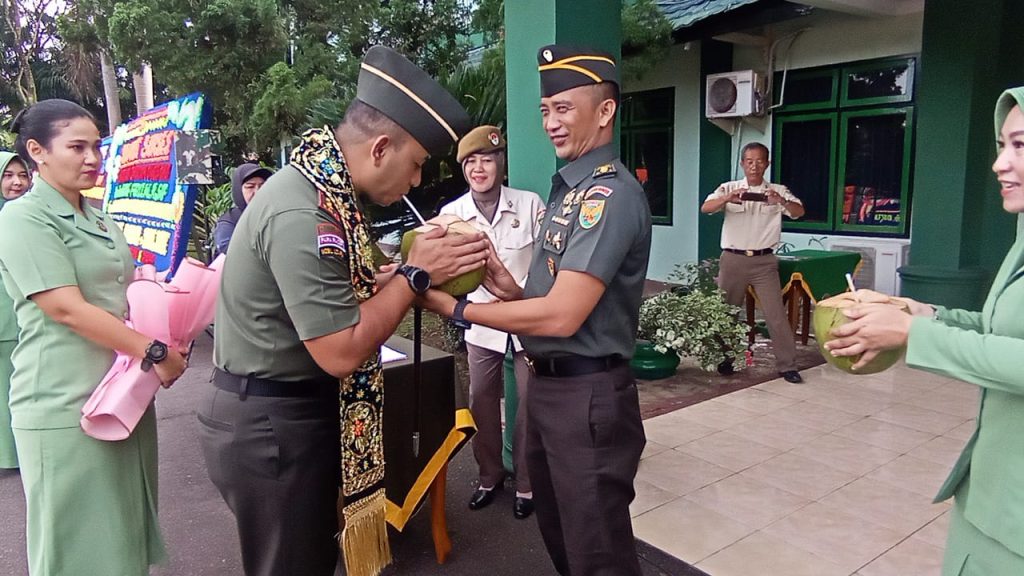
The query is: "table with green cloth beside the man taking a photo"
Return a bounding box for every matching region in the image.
[746,250,861,344]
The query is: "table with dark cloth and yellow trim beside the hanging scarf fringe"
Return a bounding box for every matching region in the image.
[384,336,476,563]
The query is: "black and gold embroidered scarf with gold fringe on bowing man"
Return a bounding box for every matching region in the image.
[291,127,391,576]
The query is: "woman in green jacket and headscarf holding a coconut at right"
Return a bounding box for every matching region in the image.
[827,87,1024,576]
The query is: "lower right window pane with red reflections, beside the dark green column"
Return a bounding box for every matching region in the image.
[842,112,907,227]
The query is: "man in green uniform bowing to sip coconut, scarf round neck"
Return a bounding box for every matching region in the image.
[199,46,487,576]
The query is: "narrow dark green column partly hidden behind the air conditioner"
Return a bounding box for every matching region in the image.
[697,40,732,260]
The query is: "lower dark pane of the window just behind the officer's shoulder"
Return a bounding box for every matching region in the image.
[627,130,672,223]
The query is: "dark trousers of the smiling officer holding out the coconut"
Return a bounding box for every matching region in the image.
[526,365,646,576]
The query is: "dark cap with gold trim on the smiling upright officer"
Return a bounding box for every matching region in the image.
[537,44,618,97]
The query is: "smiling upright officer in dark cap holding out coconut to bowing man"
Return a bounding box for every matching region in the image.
[428,45,651,576]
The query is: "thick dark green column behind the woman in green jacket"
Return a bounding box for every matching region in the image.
[899,0,1024,310]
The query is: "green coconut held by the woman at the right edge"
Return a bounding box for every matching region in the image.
[811,290,909,374]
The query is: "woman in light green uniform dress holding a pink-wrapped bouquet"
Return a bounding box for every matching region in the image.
[0,100,185,576]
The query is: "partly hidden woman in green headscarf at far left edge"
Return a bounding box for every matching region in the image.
[0,152,32,468]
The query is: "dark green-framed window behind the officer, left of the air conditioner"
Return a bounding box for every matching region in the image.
[620,87,676,225]
